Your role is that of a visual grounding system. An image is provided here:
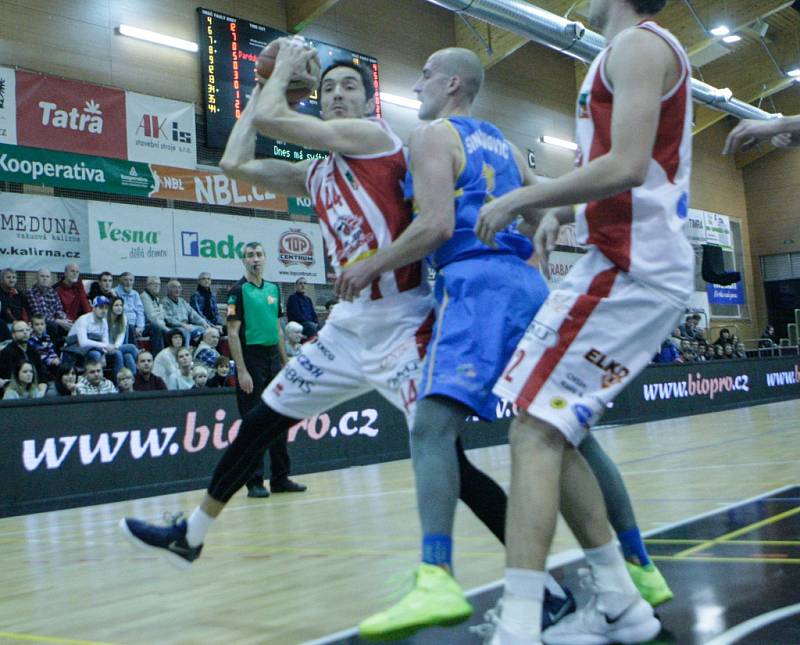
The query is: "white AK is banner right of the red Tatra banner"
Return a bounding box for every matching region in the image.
[125,92,197,168]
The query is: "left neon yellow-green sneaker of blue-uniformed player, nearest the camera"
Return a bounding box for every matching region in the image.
[358,563,472,641]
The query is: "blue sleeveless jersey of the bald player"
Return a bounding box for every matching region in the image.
[405,117,533,270]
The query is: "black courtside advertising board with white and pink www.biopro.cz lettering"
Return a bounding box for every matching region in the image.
[0,356,800,517]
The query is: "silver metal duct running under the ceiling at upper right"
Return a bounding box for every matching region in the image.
[428,0,780,119]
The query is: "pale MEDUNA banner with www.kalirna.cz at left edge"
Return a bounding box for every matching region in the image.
[0,193,89,271]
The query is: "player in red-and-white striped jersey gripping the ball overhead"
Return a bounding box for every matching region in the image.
[120,39,520,588]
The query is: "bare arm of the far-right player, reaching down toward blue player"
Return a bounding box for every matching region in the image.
[475,29,680,244]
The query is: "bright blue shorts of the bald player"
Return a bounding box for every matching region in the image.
[420,255,548,421]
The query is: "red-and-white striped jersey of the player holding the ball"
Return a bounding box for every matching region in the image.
[306,119,429,310]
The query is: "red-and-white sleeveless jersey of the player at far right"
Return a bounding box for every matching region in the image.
[576,21,694,302]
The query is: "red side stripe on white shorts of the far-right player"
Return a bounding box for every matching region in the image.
[516,267,619,410]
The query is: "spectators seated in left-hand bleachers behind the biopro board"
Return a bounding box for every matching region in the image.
[0,264,328,399]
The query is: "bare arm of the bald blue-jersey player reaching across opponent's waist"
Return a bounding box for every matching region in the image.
[335,121,462,300]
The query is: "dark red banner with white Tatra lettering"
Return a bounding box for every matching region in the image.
[16,70,127,159]
